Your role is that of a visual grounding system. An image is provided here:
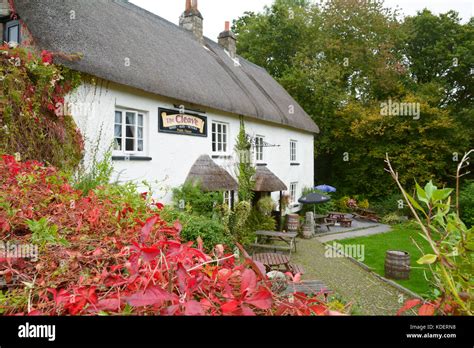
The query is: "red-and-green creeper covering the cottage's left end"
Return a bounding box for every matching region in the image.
[0,45,83,172]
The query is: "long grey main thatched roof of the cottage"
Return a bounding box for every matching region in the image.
[14,0,319,133]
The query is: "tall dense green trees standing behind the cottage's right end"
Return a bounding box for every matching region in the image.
[234,0,474,199]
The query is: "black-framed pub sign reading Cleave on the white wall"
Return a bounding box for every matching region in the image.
[158,108,207,137]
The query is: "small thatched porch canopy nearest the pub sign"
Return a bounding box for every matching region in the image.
[186,155,239,192]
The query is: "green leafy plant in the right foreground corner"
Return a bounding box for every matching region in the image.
[398,179,474,315]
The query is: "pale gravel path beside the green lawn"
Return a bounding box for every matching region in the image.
[292,239,407,315]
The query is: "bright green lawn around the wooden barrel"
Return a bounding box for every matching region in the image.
[338,223,432,296]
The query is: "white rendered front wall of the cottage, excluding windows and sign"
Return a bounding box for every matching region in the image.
[68,81,314,211]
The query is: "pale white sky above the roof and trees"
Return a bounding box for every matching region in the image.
[130,0,474,40]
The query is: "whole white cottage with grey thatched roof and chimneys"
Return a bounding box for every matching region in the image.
[7,0,319,211]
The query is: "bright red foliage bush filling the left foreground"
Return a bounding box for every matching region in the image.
[0,156,332,315]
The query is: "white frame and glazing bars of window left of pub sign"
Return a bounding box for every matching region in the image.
[113,107,148,156]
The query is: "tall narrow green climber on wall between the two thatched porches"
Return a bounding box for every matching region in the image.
[235,117,255,202]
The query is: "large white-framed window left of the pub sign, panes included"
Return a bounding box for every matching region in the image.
[114,110,145,152]
